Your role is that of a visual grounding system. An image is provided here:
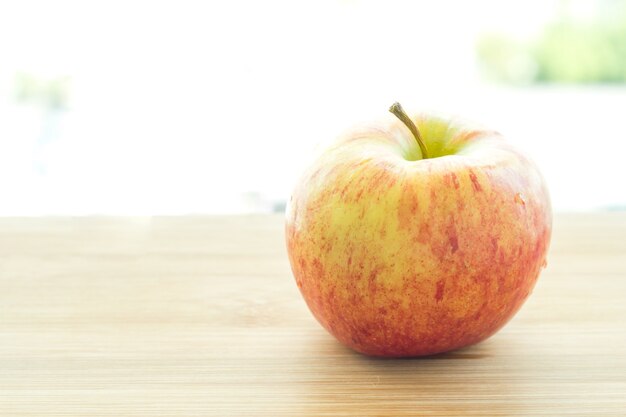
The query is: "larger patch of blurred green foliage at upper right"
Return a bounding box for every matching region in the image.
[476,6,626,84]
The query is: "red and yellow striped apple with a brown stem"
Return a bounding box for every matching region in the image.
[285,103,552,357]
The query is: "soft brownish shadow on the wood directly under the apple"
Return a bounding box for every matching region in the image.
[291,334,532,416]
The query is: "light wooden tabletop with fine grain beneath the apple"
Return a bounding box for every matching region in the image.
[0,213,626,417]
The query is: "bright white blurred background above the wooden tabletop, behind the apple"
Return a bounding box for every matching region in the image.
[0,0,626,215]
